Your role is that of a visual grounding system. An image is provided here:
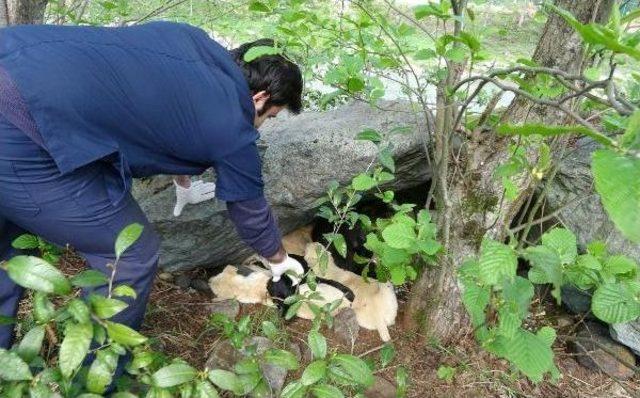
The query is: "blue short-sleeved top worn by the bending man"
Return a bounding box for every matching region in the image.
[0,22,263,201]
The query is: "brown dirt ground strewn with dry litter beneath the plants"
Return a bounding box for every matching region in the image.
[143,264,640,398]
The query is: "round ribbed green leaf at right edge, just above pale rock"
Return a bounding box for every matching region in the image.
[591,283,640,323]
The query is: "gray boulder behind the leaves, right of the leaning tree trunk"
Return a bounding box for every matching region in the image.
[547,138,640,354]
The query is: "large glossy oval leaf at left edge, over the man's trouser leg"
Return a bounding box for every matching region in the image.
[7,256,71,295]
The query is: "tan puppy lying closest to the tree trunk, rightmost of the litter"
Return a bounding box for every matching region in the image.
[304,243,398,341]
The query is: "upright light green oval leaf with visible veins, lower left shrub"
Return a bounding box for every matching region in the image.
[59,322,93,379]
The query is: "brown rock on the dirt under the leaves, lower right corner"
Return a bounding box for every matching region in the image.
[572,322,636,380]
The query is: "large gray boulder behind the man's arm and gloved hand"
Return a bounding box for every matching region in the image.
[133,102,430,271]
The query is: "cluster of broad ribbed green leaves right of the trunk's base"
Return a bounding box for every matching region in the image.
[458,228,640,382]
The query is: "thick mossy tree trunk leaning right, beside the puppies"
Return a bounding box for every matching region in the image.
[404,0,614,344]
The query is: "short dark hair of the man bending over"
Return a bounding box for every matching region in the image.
[230,39,302,113]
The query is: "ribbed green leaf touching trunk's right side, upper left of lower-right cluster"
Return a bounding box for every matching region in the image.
[478,239,518,285]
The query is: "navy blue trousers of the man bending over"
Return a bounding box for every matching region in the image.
[0,116,159,348]
